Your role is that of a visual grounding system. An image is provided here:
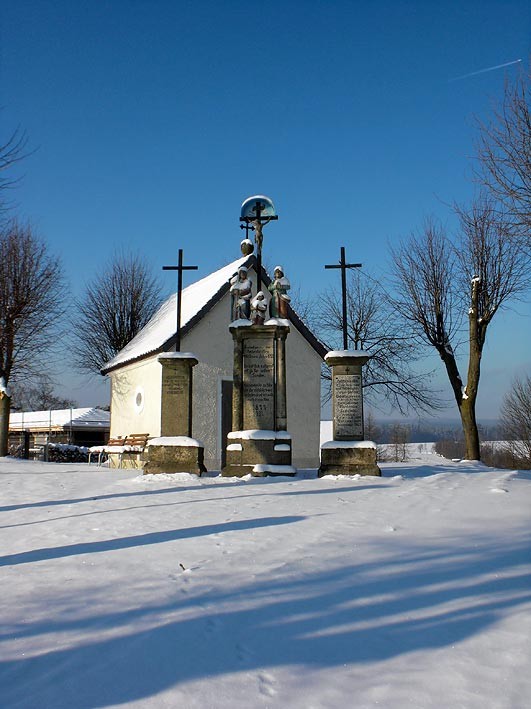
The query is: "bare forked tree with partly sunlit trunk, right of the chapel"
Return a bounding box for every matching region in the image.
[393,197,529,460]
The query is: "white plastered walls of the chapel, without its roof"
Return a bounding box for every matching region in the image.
[110,266,321,470]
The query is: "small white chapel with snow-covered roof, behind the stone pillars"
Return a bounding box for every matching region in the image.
[102,254,327,470]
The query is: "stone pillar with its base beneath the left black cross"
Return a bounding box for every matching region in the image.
[144,352,206,475]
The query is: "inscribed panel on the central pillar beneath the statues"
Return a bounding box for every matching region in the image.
[243,338,275,430]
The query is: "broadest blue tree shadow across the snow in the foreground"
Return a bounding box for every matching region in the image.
[0,532,531,709]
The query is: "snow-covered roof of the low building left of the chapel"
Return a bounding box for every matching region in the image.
[9,408,111,431]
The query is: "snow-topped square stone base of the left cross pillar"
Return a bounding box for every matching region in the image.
[144,436,207,475]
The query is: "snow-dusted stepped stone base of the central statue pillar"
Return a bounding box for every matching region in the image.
[221,430,297,477]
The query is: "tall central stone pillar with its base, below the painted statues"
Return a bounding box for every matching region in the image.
[222,321,296,476]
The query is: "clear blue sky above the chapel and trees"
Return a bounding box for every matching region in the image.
[0,0,531,418]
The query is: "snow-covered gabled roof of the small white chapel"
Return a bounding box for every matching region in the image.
[101,254,327,374]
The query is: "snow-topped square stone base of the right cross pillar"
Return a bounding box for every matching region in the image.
[318,441,382,478]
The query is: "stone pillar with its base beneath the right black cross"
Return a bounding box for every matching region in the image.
[319,350,381,476]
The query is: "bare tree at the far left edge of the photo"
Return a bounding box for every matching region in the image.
[0,220,64,455]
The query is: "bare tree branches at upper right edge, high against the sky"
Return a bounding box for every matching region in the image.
[476,66,531,247]
